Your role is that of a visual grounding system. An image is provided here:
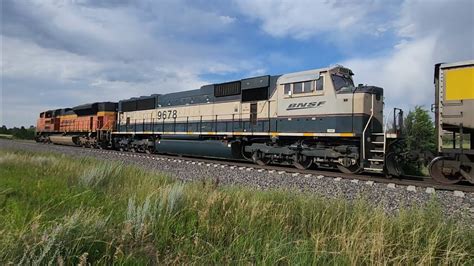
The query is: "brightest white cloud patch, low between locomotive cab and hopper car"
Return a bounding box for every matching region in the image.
[341,37,436,111]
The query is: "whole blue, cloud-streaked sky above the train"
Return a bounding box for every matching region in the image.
[0,0,474,127]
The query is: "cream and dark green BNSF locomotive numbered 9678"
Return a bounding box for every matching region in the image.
[113,66,402,175]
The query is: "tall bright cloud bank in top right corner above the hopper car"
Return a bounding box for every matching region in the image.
[342,0,474,111]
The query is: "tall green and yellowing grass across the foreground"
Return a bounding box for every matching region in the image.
[0,150,474,265]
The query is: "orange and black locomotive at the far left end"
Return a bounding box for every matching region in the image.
[36,102,117,148]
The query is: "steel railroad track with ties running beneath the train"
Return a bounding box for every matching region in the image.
[1,141,474,193]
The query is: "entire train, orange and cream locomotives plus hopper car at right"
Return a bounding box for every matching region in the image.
[36,62,474,183]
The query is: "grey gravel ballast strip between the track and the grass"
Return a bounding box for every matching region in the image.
[0,139,474,227]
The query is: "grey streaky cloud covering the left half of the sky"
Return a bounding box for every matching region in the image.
[0,0,259,125]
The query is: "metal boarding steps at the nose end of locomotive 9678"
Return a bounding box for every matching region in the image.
[364,133,387,173]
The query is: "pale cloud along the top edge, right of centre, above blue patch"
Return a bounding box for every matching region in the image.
[236,0,393,39]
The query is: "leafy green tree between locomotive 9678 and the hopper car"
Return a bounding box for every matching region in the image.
[405,106,436,174]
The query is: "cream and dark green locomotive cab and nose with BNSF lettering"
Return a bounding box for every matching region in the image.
[278,66,383,137]
